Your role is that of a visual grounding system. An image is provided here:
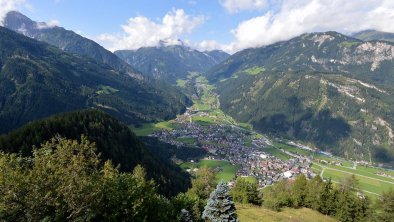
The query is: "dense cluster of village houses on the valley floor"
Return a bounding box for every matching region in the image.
[153,116,314,188]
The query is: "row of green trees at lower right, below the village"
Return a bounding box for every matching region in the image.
[231,174,394,222]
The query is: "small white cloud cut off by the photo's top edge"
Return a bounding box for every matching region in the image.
[219,0,267,13]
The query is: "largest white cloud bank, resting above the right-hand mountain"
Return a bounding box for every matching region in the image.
[225,0,394,52]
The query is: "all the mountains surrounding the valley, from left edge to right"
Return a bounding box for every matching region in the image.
[0,12,394,166]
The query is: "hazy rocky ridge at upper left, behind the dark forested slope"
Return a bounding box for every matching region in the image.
[3,11,142,78]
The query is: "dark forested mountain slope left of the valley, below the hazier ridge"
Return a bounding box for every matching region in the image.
[0,27,190,134]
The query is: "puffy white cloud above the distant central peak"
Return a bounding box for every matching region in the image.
[96,9,205,50]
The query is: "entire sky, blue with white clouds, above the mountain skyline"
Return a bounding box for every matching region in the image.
[0,0,394,52]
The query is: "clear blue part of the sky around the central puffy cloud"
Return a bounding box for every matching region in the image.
[16,0,263,43]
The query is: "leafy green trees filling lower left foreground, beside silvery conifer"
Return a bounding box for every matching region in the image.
[0,136,236,221]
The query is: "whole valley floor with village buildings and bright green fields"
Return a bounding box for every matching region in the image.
[133,73,394,198]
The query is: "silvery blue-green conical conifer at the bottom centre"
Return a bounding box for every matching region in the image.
[202,182,238,222]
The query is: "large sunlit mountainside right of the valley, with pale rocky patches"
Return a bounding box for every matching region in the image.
[206,32,394,163]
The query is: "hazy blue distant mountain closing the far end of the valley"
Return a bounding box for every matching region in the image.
[115,44,229,84]
